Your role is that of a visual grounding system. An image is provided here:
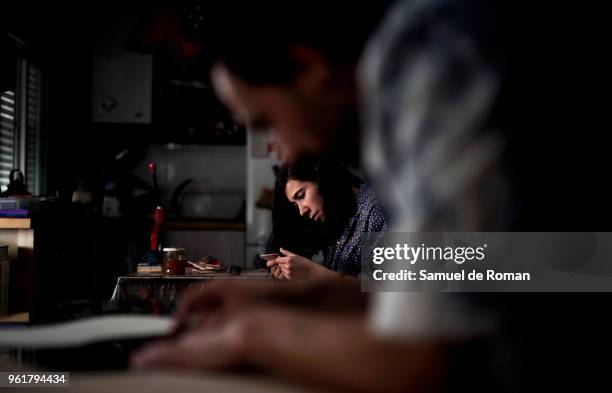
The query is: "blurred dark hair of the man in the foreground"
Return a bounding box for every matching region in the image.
[201,0,388,84]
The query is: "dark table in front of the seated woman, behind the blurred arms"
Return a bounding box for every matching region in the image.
[111,269,272,313]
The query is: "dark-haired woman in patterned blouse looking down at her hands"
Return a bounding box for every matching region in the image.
[267,157,387,280]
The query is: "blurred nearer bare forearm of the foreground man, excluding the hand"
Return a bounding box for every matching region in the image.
[245,310,442,392]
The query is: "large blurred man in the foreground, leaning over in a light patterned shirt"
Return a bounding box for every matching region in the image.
[133,1,608,392]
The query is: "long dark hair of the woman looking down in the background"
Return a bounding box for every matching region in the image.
[268,157,361,258]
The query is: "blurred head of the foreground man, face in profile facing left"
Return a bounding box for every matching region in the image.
[204,1,385,162]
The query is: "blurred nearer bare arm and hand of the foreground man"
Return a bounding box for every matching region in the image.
[131,305,445,393]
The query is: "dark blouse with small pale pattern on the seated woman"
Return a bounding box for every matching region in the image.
[323,183,388,276]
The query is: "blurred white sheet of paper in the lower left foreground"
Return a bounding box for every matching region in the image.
[0,315,172,348]
